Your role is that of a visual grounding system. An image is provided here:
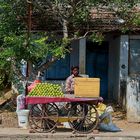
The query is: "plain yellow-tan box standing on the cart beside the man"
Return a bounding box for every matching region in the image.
[74,77,100,97]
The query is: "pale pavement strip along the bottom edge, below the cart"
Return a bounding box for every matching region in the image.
[0,128,140,140]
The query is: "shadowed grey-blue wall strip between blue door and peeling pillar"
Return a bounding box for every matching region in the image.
[108,36,120,101]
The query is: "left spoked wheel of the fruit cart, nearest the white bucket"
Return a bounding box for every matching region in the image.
[29,103,58,133]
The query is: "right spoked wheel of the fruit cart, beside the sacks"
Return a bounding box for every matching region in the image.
[68,103,99,134]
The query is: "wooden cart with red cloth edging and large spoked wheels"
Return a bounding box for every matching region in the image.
[26,82,103,133]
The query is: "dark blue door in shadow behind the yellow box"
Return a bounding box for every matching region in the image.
[86,42,109,99]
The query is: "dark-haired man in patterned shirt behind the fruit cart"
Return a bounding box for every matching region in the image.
[65,66,80,94]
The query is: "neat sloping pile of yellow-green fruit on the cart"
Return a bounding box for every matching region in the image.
[28,83,64,97]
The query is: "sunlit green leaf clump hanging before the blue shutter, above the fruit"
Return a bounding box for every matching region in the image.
[28,34,69,62]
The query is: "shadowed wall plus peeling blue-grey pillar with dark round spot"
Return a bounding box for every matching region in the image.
[109,35,129,106]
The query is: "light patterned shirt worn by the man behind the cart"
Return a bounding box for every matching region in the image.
[65,74,75,93]
